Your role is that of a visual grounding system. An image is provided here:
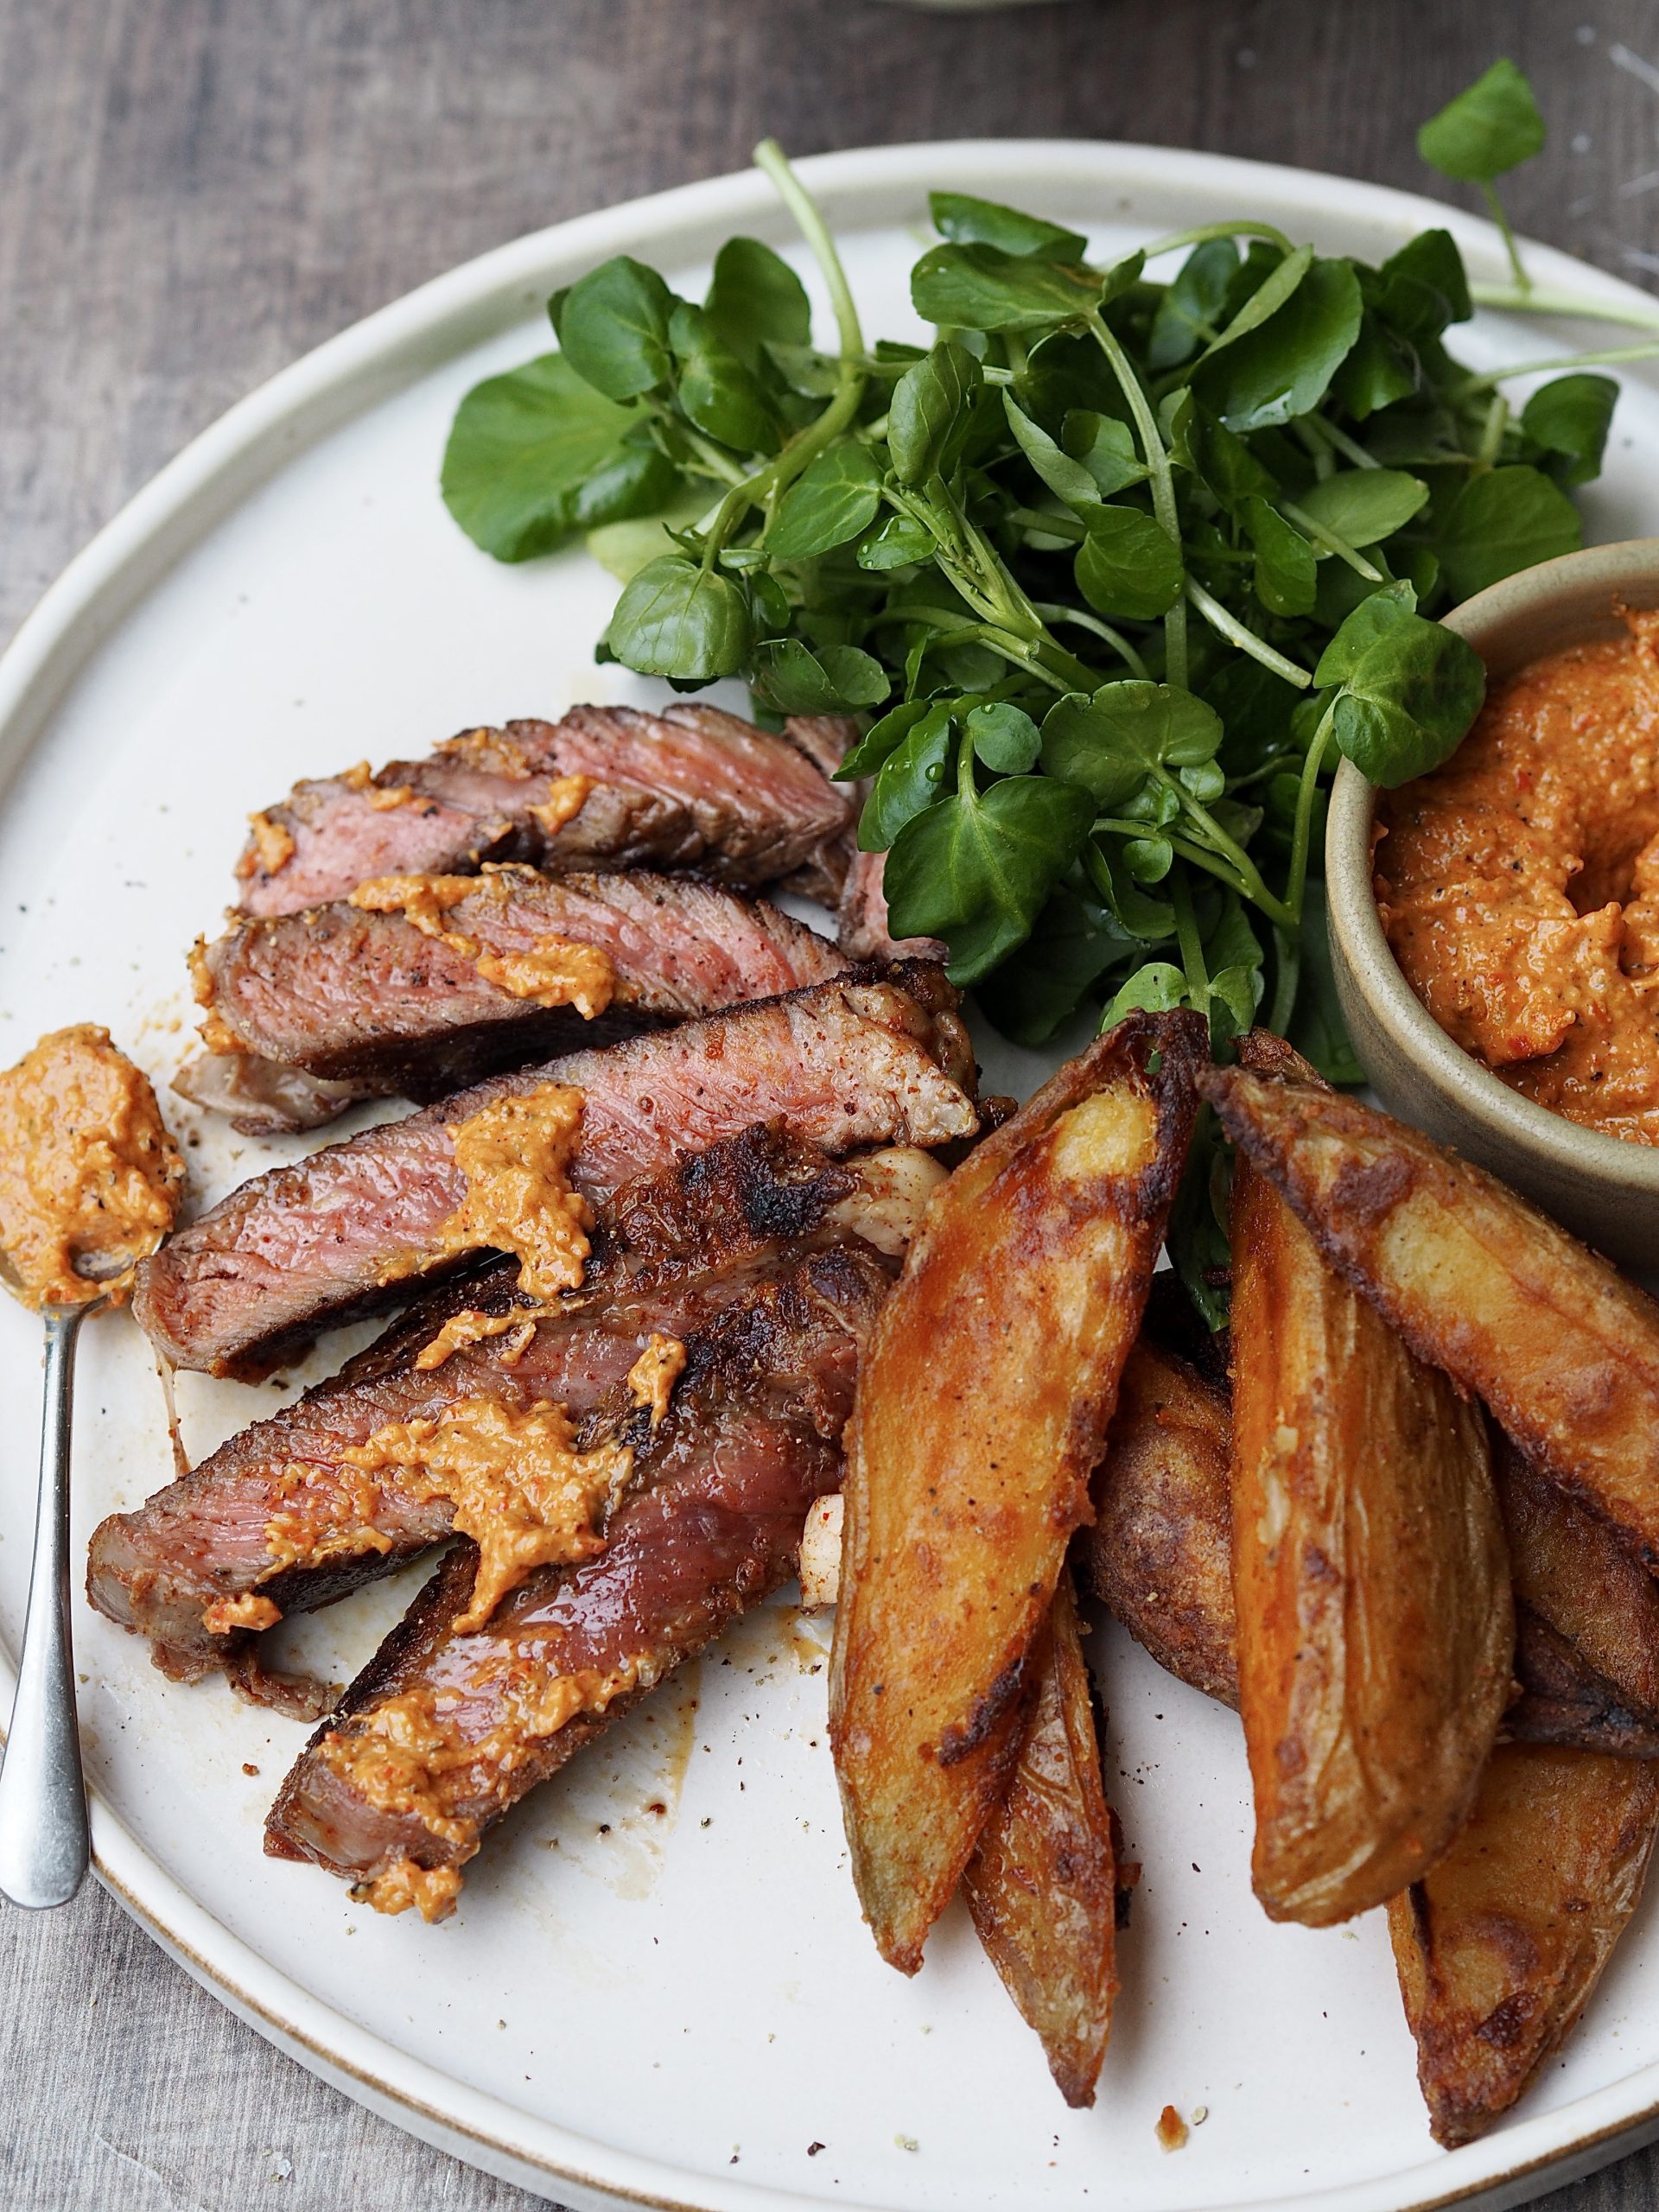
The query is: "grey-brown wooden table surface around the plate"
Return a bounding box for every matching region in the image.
[0,0,1659,2212]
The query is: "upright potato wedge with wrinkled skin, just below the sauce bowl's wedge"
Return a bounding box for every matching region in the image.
[1232,1033,1516,1927]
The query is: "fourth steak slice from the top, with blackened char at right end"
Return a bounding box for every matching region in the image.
[86,1128,911,1681]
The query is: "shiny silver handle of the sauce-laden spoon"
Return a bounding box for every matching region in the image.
[0,1305,91,1904]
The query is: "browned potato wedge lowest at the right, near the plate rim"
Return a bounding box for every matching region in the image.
[1389,1743,1659,2148]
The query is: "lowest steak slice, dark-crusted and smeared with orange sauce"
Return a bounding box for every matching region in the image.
[265,1249,887,1913]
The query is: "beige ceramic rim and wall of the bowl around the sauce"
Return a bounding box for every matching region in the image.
[1325,537,1659,1272]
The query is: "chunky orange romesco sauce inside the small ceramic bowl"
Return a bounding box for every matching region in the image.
[1374,613,1659,1144]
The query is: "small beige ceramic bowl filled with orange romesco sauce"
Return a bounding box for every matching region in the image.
[1325,537,1659,1269]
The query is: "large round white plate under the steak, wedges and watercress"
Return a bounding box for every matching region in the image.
[0,143,1659,2212]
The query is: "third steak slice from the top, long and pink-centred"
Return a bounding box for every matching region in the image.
[133,964,976,1376]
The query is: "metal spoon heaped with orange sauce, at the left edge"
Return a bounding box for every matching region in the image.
[0,1024,183,1907]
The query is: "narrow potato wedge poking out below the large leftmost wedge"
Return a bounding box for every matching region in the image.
[963,1573,1117,2106]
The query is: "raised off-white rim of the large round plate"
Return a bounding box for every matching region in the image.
[0,139,1659,2212]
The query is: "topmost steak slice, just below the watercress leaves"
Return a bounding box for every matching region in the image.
[237,703,847,916]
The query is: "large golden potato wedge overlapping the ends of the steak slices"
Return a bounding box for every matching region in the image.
[830,1013,1208,1974]
